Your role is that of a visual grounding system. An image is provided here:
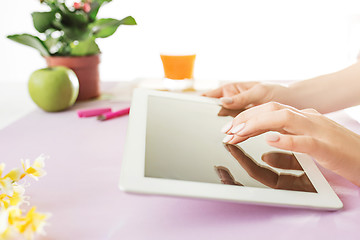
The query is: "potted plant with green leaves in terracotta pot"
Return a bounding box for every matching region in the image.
[7,0,136,100]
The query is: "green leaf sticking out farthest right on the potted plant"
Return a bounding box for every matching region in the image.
[90,16,136,38]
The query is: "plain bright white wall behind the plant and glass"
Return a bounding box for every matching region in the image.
[0,0,360,84]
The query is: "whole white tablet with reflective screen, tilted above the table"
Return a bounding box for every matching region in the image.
[119,89,343,210]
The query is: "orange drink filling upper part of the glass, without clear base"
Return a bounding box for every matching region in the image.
[160,54,196,80]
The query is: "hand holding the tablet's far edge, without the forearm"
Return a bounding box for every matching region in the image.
[203,82,287,109]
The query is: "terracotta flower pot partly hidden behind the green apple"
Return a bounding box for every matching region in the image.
[45,55,100,100]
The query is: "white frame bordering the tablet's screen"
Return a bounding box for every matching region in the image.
[119,88,343,210]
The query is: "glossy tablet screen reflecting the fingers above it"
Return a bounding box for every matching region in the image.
[144,96,316,192]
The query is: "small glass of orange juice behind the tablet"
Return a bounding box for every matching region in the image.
[160,53,196,91]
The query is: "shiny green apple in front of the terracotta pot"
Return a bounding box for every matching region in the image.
[28,66,79,112]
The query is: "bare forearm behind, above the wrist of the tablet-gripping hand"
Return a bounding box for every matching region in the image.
[275,59,360,113]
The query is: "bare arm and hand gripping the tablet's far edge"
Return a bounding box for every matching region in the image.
[204,62,360,113]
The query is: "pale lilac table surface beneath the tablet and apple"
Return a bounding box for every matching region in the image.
[0,82,360,240]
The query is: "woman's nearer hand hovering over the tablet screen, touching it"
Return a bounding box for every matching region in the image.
[223,102,360,186]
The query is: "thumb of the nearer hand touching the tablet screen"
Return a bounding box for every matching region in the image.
[265,133,322,156]
